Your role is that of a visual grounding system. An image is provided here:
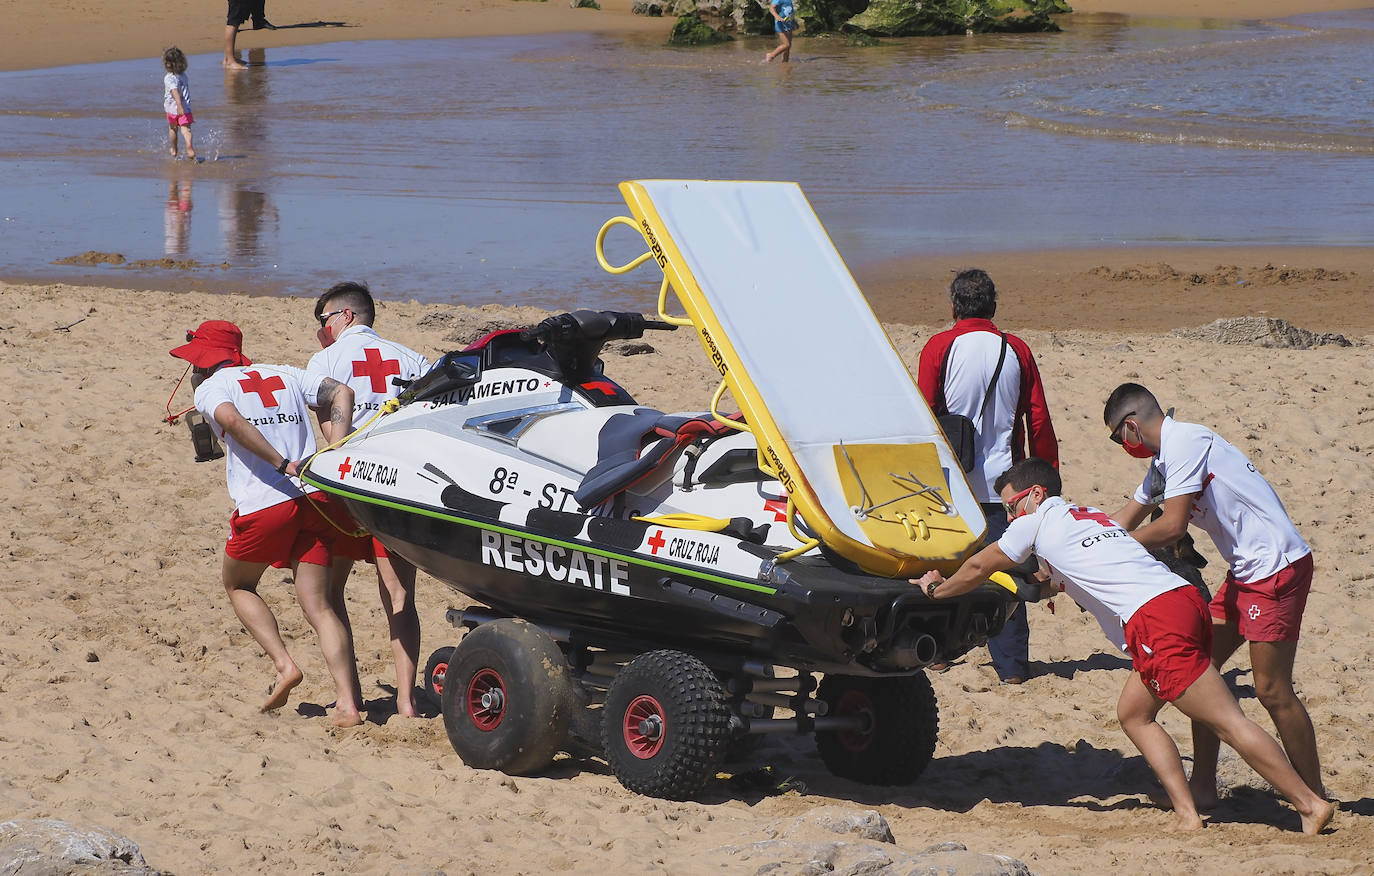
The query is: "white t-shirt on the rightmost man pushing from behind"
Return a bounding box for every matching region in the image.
[1135,417,1312,582]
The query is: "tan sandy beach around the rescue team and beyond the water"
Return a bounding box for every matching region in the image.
[0,0,1374,876]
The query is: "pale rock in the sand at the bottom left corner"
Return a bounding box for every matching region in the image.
[0,818,159,876]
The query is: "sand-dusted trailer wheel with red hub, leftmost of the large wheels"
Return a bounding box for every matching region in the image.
[441,618,576,776]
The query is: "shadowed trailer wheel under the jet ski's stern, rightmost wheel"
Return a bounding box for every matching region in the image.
[816,673,940,785]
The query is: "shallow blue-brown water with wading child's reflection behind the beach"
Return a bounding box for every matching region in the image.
[0,10,1374,306]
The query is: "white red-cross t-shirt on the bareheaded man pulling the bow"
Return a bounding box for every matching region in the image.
[305,325,430,428]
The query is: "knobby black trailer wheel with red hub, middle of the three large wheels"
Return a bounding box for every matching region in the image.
[602,651,730,800]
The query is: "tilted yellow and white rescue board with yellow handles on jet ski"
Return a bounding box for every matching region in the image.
[596,180,985,577]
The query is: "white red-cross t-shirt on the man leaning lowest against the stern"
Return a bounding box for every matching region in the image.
[998,496,1187,648]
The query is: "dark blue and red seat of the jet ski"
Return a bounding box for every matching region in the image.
[573,408,741,512]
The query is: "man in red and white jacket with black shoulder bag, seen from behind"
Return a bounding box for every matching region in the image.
[916,268,1059,684]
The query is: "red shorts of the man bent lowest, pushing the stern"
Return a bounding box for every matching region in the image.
[1125,584,1212,703]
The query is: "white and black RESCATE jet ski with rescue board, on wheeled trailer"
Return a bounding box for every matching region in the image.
[304,180,1029,799]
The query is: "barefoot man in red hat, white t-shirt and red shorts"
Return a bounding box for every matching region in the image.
[170,320,363,726]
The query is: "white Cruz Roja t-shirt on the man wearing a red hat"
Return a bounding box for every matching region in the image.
[195,365,324,515]
